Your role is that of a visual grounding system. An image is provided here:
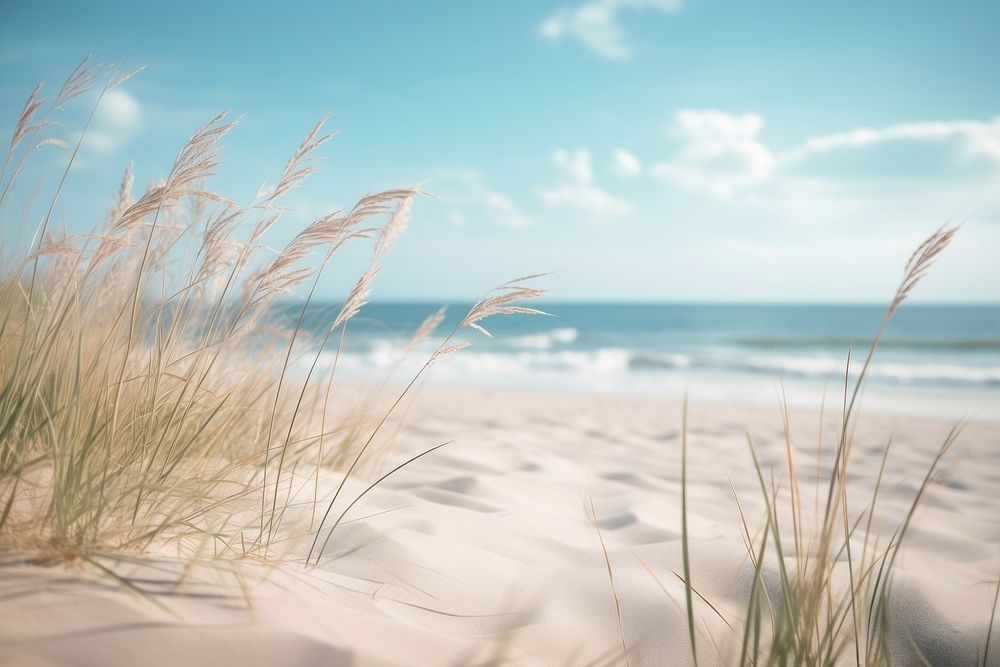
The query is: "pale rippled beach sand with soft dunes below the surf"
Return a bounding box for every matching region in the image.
[0,388,1000,667]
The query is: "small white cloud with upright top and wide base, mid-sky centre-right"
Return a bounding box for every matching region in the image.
[538,148,632,220]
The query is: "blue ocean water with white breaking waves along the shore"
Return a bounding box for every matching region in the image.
[282,303,1000,420]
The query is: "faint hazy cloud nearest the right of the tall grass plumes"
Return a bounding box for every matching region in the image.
[434,170,531,227]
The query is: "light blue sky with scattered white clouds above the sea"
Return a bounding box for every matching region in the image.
[0,0,1000,303]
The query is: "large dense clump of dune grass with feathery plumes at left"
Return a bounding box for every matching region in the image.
[0,59,542,563]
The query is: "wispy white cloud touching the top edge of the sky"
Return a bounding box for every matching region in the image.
[540,0,682,60]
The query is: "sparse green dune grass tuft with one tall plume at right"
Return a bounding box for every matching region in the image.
[664,228,996,665]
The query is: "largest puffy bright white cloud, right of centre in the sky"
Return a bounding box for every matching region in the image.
[652,109,775,199]
